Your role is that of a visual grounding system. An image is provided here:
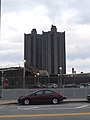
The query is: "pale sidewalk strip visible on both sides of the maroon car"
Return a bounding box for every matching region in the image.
[0,98,87,105]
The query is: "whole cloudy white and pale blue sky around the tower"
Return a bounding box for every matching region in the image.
[0,0,90,73]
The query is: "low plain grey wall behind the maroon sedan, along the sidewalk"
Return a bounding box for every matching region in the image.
[0,88,90,100]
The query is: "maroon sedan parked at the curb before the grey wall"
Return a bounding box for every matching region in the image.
[18,90,66,105]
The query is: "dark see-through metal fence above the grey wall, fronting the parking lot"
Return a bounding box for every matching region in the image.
[0,76,90,89]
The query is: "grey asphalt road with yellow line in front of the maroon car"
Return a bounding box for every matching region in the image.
[0,102,90,120]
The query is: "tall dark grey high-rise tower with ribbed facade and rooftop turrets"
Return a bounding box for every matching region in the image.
[24,25,66,75]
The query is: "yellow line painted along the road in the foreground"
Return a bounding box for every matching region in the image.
[0,112,90,118]
